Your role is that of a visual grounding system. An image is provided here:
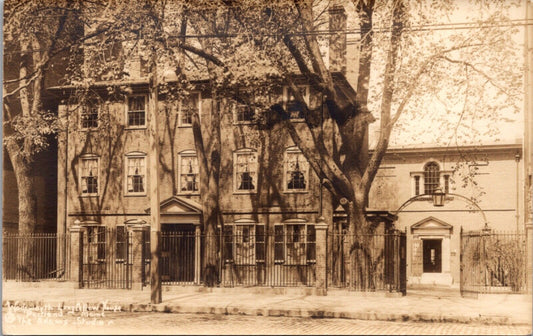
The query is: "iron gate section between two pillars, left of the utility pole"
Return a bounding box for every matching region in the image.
[80,226,132,289]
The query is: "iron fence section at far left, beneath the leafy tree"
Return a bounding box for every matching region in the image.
[2,233,70,281]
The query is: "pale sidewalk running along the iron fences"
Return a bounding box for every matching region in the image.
[2,282,532,325]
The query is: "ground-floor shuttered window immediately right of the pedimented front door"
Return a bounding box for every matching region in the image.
[223,220,265,265]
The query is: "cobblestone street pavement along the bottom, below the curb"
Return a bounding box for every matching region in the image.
[3,311,531,335]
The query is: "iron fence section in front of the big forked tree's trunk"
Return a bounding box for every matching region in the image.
[329,231,406,293]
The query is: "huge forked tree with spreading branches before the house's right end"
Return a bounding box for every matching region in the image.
[174,0,521,288]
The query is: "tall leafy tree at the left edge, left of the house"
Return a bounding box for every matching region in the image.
[3,1,88,233]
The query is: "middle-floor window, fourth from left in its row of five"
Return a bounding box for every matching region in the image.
[234,149,257,192]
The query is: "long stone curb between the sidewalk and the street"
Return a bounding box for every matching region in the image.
[2,300,529,325]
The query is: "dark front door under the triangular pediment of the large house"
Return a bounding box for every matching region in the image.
[161,224,196,283]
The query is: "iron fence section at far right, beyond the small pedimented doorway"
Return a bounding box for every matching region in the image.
[461,231,527,295]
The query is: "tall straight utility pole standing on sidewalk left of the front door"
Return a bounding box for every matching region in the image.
[148,46,162,304]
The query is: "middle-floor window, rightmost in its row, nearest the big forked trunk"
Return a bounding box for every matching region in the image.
[285,147,309,191]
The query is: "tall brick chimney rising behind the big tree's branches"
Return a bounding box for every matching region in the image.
[328,4,346,74]
